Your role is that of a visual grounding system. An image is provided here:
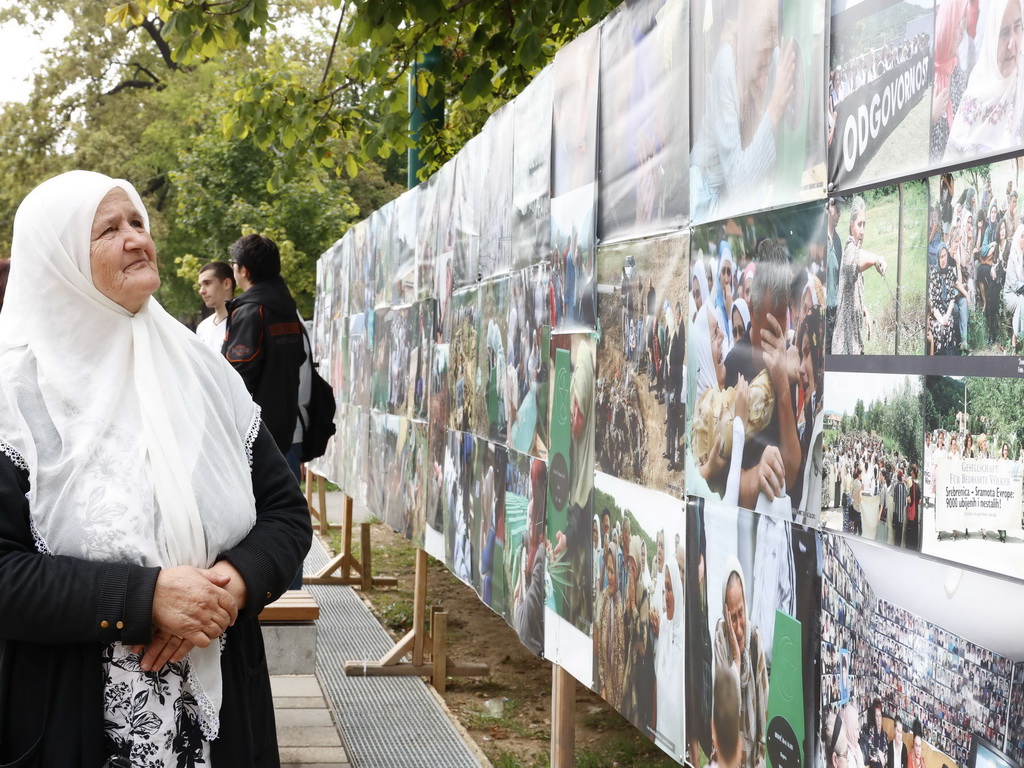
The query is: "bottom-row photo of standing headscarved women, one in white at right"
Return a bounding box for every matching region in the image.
[594,472,686,760]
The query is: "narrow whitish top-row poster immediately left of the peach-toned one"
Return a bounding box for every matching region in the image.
[512,67,554,269]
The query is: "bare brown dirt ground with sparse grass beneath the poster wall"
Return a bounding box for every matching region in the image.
[328,522,676,768]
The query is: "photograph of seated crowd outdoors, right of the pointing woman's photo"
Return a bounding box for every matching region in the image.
[927,159,1024,355]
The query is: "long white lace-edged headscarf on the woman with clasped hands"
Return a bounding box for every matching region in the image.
[0,171,259,739]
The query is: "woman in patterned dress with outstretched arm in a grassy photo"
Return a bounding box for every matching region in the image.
[830,196,886,354]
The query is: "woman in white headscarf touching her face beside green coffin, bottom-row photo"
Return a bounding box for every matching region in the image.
[715,557,768,768]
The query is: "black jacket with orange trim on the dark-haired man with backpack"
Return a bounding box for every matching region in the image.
[221,274,306,453]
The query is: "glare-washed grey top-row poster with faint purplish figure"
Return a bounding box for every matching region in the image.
[597,0,690,243]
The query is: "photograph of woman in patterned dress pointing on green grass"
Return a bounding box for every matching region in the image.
[823,186,928,354]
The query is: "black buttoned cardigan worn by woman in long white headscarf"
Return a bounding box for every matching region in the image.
[0,427,312,768]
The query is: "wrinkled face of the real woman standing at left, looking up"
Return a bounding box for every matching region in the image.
[89,187,160,312]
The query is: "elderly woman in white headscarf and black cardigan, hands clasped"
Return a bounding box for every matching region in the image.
[0,171,311,766]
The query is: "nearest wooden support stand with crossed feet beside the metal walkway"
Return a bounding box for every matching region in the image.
[345,549,490,693]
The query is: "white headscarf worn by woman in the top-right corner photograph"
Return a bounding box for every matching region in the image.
[945,0,1024,161]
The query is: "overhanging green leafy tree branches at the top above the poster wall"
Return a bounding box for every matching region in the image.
[97,0,622,188]
